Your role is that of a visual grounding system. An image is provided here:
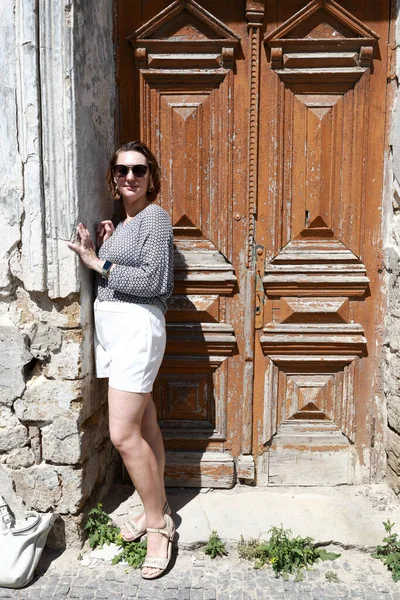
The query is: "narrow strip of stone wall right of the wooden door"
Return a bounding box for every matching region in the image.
[384,0,400,494]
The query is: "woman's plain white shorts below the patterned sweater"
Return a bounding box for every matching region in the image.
[94,299,166,393]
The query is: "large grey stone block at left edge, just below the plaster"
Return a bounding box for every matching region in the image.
[0,325,32,406]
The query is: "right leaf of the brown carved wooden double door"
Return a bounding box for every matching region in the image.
[255,0,389,484]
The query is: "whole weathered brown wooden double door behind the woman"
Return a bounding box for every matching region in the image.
[116,0,390,487]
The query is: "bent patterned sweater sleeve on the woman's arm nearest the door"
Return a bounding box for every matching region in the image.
[108,212,173,298]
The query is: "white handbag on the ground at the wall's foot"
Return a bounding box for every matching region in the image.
[0,511,56,588]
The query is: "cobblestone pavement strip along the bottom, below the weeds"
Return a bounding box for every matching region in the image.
[0,548,400,600]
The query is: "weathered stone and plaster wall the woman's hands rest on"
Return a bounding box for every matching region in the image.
[0,0,117,543]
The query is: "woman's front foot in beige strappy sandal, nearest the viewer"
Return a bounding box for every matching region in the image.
[142,515,175,579]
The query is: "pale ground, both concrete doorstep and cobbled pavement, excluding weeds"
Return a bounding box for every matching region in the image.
[0,484,400,600]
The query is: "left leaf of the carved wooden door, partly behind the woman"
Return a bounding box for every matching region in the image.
[117,0,253,487]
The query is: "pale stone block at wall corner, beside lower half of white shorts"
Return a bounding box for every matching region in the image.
[43,329,82,379]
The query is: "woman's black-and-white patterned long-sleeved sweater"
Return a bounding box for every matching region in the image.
[96,204,174,312]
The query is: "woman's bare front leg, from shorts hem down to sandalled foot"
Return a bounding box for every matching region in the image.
[108,387,168,575]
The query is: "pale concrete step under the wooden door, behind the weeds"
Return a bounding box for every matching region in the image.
[103,484,400,550]
